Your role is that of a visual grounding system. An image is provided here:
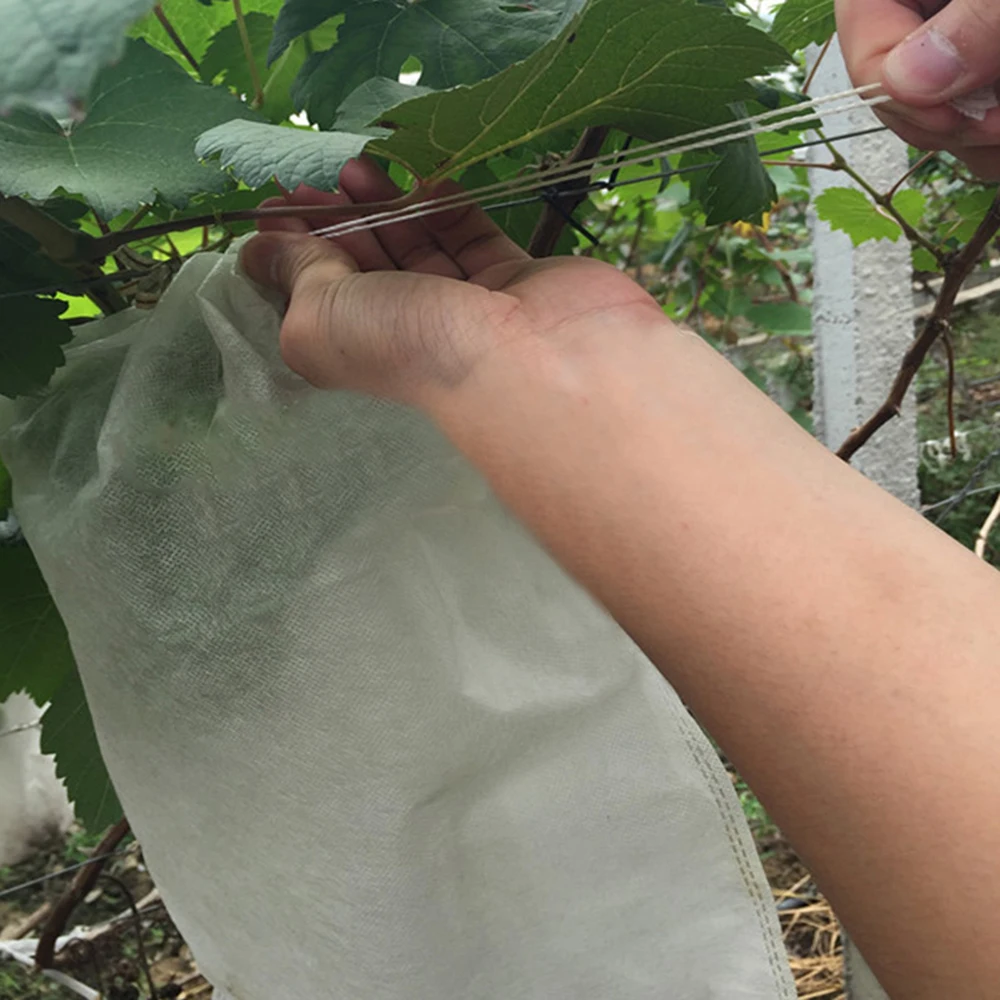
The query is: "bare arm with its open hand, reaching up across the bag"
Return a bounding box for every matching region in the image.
[243,162,1000,1000]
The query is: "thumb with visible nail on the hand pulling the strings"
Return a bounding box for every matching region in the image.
[884,0,1000,106]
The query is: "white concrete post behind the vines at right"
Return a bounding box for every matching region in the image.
[810,42,920,1000]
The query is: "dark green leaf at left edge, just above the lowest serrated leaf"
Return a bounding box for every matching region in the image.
[0,544,76,705]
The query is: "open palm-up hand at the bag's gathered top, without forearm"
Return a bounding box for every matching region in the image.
[242,160,666,405]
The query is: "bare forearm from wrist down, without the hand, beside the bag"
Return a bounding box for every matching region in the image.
[430,308,1000,998]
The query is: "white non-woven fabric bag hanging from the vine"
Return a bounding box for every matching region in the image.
[0,253,794,1000]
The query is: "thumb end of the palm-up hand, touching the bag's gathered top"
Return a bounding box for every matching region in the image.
[240,232,358,298]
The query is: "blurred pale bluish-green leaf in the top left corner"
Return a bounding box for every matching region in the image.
[0,0,153,118]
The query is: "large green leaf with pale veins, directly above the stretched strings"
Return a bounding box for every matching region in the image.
[382,0,787,176]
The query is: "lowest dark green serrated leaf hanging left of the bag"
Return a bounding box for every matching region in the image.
[42,668,122,830]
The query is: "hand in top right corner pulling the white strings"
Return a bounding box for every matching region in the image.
[837,0,1000,180]
